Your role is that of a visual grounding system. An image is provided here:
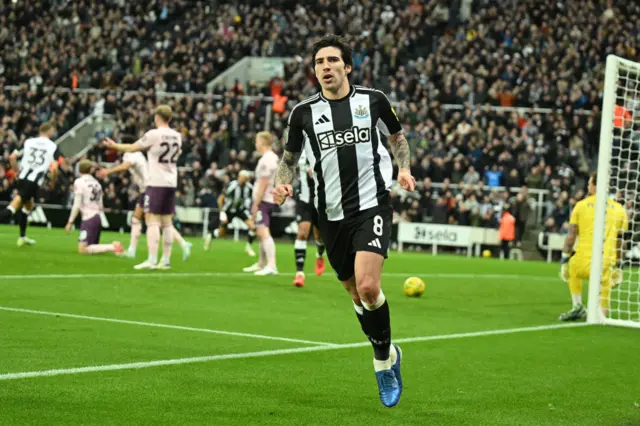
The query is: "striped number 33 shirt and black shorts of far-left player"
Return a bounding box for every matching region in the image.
[17,136,62,203]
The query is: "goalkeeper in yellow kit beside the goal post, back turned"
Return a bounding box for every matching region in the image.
[559,173,629,321]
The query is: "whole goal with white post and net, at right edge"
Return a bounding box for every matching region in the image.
[587,55,640,327]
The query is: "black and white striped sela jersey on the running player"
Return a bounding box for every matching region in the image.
[286,86,402,221]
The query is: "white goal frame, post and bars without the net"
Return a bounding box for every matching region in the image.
[587,55,640,328]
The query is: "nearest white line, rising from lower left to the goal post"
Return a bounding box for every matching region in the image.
[0,323,587,381]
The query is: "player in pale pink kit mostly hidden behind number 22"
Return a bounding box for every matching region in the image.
[97,138,192,260]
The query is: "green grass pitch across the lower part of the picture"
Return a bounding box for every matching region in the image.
[0,227,640,425]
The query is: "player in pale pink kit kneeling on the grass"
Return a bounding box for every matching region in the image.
[64,160,124,255]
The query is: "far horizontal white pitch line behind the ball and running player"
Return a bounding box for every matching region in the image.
[0,272,557,281]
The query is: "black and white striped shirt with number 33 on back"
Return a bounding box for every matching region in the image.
[18,137,61,185]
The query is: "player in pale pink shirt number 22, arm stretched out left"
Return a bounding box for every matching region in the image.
[104,105,182,269]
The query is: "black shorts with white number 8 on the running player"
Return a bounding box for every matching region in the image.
[318,204,393,281]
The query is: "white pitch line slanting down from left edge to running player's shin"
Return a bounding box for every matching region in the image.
[0,306,335,346]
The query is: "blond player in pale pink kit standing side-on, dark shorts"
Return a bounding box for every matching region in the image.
[243,132,280,275]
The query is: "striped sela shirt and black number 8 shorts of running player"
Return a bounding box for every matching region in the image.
[286,86,402,280]
